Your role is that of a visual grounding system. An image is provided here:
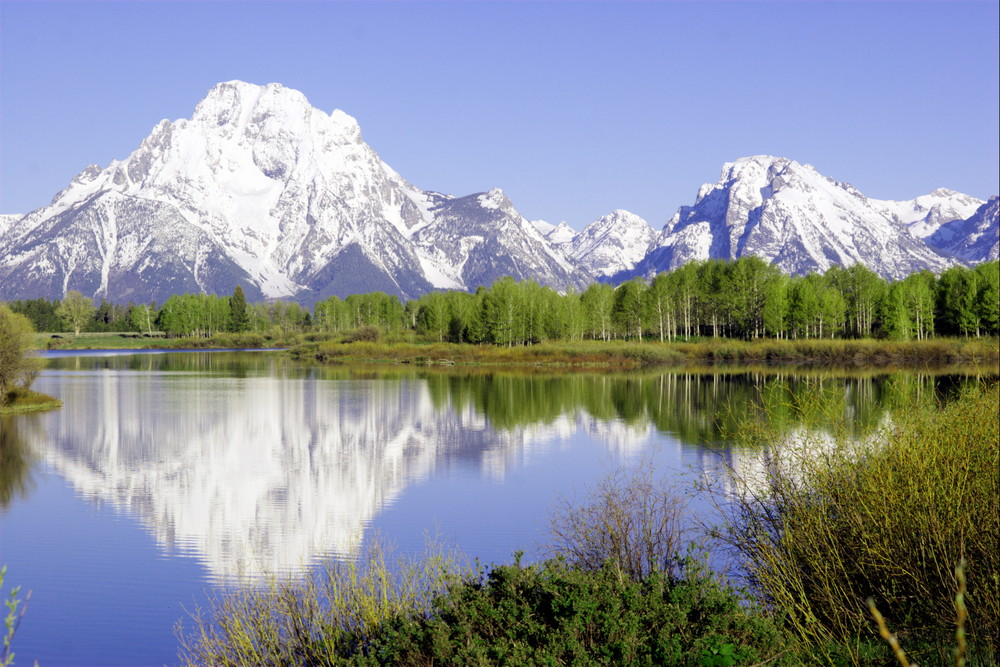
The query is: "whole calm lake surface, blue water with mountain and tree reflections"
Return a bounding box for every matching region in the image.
[0,352,988,666]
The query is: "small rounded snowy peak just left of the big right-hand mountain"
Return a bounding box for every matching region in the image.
[567,209,656,278]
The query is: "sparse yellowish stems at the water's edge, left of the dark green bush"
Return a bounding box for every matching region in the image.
[176,536,472,667]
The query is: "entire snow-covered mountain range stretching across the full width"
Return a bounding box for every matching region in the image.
[0,81,1000,304]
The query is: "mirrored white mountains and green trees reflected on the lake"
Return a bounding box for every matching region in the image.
[7,353,992,580]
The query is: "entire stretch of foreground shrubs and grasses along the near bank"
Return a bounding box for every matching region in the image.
[180,382,1000,665]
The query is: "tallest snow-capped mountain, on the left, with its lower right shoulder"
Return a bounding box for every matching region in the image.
[0,81,589,302]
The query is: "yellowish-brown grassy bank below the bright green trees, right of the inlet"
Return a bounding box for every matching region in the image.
[304,338,1000,368]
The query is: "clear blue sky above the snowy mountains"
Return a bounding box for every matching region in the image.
[0,0,1000,229]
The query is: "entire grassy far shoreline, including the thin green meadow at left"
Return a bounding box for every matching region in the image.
[36,334,1000,369]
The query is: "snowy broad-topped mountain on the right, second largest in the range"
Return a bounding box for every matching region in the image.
[636,155,949,278]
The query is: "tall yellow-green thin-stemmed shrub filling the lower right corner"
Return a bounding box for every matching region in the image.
[723,384,1000,664]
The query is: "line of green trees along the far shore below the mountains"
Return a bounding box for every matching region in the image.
[3,257,1000,346]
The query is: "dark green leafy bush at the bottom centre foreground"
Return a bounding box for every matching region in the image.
[378,555,790,665]
